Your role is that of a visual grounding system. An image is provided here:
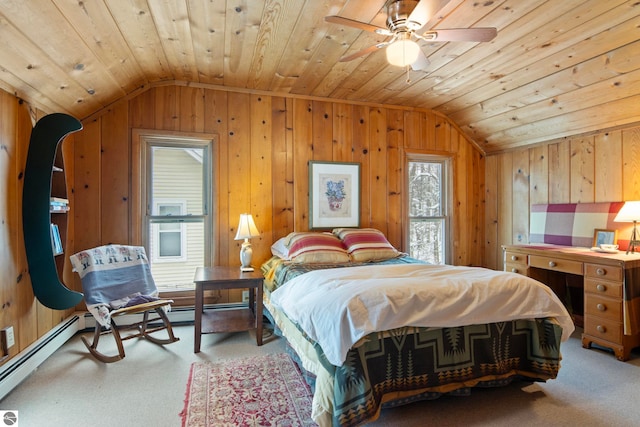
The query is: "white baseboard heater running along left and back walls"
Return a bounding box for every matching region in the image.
[0,303,242,401]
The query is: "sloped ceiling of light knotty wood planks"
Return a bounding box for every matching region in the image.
[0,0,640,153]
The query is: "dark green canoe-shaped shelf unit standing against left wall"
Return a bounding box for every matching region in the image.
[22,113,83,310]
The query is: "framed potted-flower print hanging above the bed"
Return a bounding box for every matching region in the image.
[309,161,360,230]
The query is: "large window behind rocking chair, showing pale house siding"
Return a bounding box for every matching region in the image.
[133,131,214,292]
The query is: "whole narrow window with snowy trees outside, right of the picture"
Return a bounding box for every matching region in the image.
[406,155,449,264]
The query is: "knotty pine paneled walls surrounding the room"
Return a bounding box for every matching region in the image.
[0,81,640,368]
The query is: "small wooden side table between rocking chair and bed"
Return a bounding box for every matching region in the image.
[193,266,264,353]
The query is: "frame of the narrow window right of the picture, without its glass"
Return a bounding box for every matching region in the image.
[404,153,453,264]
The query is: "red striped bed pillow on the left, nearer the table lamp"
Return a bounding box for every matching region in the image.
[285,232,350,264]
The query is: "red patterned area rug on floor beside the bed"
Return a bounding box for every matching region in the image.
[180,353,316,427]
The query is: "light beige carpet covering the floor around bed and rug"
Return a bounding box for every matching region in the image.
[0,326,640,427]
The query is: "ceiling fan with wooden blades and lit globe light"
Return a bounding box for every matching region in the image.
[324,0,498,70]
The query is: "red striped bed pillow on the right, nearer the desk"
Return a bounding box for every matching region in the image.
[333,228,400,262]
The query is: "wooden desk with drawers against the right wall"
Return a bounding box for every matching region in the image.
[502,244,640,361]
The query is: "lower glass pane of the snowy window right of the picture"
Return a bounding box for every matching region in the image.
[409,219,445,264]
